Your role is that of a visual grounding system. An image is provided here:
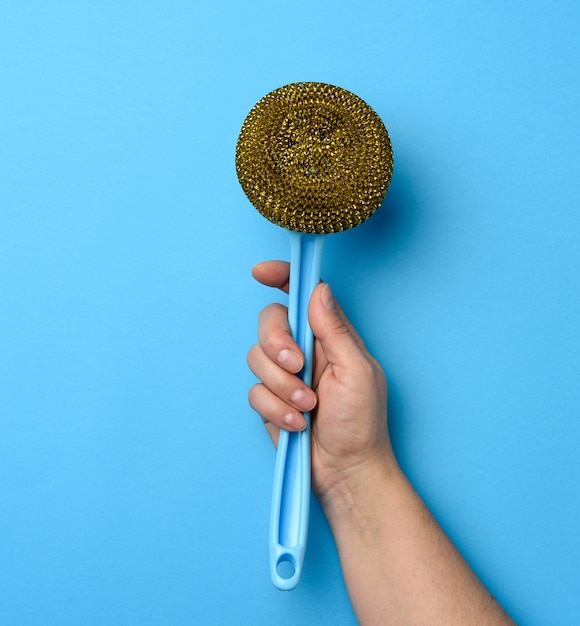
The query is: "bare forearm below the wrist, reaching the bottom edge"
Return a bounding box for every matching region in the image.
[322,462,512,626]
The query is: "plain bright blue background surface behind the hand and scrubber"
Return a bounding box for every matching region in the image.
[0,0,580,626]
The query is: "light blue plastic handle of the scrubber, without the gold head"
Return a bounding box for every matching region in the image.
[270,231,325,591]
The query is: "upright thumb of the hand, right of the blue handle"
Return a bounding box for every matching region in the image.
[308,283,361,368]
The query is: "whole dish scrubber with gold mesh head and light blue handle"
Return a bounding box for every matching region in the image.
[236,83,393,590]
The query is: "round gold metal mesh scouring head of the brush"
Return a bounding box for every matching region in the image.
[236,82,393,234]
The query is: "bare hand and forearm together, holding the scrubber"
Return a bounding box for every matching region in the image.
[248,261,513,626]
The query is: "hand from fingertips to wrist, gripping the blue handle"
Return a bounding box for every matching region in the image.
[248,261,396,500]
